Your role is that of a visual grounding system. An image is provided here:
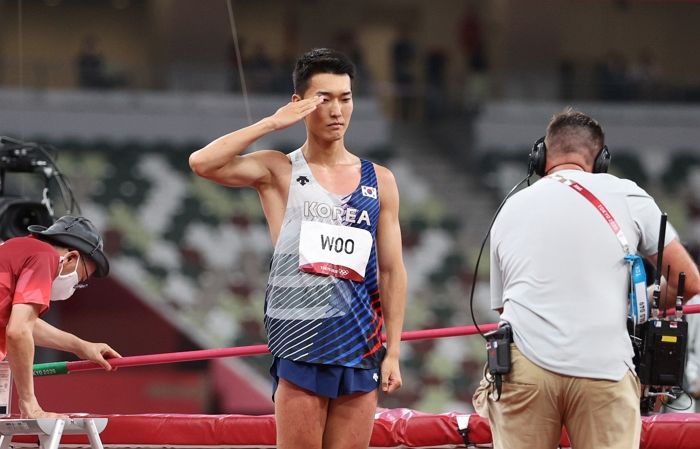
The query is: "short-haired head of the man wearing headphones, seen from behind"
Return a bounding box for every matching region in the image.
[545,108,605,167]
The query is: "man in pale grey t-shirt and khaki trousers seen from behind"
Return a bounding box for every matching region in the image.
[474,109,700,449]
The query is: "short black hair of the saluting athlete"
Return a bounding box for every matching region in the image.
[292,48,355,95]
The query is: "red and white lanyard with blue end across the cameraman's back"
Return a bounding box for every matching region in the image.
[548,173,649,324]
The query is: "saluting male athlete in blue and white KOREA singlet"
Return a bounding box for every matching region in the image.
[190,49,406,449]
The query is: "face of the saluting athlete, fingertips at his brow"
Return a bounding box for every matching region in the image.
[295,73,352,140]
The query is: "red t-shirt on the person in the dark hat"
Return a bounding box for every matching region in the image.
[0,237,59,360]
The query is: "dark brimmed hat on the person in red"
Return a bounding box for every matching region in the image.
[27,215,109,278]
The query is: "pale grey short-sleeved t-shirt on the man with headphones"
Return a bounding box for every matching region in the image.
[491,170,677,380]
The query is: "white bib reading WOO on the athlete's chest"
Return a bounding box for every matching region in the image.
[299,221,373,282]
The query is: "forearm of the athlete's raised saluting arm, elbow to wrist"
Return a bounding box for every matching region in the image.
[189,117,277,178]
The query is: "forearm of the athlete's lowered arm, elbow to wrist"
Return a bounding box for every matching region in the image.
[380,267,406,357]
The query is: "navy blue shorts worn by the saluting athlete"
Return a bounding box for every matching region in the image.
[270,357,381,400]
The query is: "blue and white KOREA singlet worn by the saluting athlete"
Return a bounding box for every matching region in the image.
[265,149,384,368]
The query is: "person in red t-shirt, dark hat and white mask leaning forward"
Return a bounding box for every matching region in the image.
[0,215,121,418]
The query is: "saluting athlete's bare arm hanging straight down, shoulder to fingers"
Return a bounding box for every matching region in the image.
[375,165,407,393]
